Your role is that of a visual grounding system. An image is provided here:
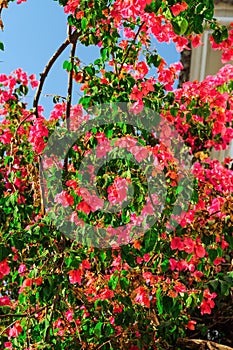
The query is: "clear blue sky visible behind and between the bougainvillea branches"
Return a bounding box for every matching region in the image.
[0,0,179,117]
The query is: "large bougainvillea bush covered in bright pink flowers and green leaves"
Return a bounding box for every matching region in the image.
[0,0,233,350]
